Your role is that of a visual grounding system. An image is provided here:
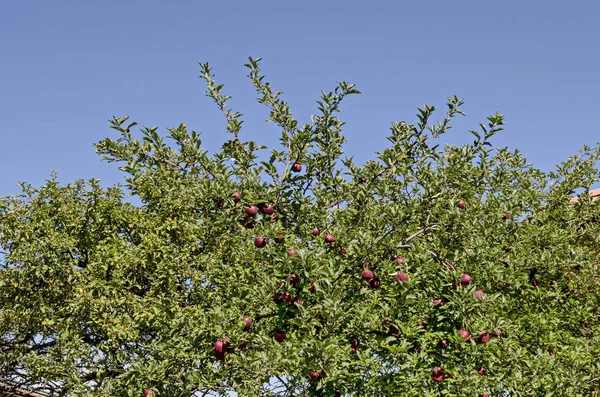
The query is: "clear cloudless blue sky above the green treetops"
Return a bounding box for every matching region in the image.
[0,0,600,195]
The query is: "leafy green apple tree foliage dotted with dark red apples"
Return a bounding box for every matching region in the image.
[0,58,600,396]
